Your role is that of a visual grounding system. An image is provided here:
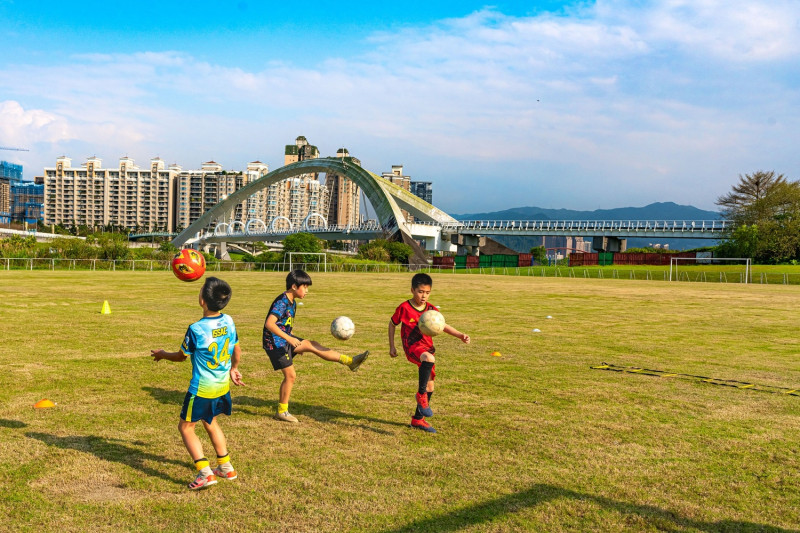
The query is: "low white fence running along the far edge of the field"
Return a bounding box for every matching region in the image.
[0,257,800,285]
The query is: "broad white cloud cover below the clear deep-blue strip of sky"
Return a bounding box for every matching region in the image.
[0,0,800,212]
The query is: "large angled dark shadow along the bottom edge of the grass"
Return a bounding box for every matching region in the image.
[383,484,799,533]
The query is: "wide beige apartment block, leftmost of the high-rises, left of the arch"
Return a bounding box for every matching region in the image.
[42,156,175,231]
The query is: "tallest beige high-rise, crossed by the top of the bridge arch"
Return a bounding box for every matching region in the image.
[265,135,328,228]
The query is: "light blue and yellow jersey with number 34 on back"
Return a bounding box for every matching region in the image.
[181,314,239,398]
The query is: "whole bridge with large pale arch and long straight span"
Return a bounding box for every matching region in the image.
[170,157,731,264]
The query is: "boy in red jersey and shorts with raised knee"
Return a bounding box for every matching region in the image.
[389,273,469,433]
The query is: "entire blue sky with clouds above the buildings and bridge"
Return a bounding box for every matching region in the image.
[0,0,800,213]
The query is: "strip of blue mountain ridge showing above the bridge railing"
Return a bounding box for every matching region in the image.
[452,202,720,220]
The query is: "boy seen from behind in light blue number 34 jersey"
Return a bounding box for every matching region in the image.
[151,277,244,490]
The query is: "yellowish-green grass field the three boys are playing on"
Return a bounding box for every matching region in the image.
[0,271,800,533]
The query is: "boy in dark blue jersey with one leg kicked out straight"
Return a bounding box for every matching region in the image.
[262,270,369,423]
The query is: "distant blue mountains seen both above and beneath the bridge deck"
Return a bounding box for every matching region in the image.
[452,202,720,252]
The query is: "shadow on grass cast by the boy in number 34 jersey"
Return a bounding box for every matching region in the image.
[25,432,188,486]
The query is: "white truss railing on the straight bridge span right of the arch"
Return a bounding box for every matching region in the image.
[415,220,731,234]
